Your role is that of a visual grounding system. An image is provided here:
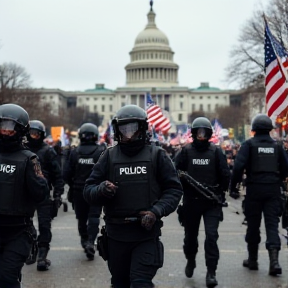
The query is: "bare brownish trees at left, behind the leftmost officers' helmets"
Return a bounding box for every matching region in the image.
[0,63,99,130]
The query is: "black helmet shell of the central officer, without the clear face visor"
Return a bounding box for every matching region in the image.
[111,105,148,141]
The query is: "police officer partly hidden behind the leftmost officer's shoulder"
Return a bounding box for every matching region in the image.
[26,120,64,271]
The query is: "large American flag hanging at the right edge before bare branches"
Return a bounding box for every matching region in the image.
[265,20,288,122]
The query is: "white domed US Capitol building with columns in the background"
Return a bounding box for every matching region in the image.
[39,1,241,130]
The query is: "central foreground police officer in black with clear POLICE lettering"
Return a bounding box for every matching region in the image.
[84,105,182,288]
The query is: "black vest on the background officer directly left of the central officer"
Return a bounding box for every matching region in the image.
[73,145,104,190]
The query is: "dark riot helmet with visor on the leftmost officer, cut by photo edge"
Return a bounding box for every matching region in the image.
[0,104,29,145]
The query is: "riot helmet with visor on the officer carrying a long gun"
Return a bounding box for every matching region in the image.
[191,117,213,141]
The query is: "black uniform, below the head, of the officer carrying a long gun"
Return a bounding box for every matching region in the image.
[175,143,230,271]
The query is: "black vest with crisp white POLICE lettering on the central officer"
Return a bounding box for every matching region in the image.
[105,145,161,218]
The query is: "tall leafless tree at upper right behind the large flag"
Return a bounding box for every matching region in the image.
[226,0,288,88]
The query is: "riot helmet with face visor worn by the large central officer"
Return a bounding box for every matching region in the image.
[112,105,148,143]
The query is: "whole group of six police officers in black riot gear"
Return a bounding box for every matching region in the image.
[0,104,288,288]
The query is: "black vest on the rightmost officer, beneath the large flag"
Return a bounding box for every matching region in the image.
[248,138,280,183]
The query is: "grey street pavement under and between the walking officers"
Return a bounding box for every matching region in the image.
[22,191,288,288]
